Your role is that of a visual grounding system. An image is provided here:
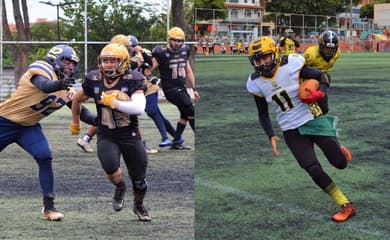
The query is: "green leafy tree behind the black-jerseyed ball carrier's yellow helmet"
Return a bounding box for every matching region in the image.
[63,0,165,71]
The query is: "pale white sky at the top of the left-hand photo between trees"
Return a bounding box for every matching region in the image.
[3,0,165,24]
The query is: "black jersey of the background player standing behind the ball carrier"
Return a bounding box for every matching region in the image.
[152,45,190,91]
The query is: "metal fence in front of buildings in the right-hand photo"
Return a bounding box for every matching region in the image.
[195,8,390,47]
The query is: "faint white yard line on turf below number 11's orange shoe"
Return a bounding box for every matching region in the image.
[195,177,390,239]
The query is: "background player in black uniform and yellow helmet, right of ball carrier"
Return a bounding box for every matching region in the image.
[152,27,200,150]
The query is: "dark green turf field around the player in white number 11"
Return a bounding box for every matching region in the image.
[195,53,390,240]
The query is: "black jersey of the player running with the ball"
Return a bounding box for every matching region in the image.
[82,70,145,137]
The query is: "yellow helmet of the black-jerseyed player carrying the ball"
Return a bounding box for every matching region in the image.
[98,43,130,80]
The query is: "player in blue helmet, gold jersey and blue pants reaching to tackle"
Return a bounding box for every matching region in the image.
[0,45,96,221]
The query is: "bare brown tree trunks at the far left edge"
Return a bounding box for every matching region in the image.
[2,0,31,86]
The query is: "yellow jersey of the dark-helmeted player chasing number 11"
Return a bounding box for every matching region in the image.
[303,45,341,72]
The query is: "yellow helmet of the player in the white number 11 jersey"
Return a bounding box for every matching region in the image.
[248,37,280,78]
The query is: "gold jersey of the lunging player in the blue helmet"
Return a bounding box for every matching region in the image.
[0,61,74,126]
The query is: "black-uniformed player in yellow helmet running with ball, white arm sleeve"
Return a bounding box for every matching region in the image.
[71,43,151,221]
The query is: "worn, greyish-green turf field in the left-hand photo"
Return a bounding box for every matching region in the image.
[0,103,194,240]
